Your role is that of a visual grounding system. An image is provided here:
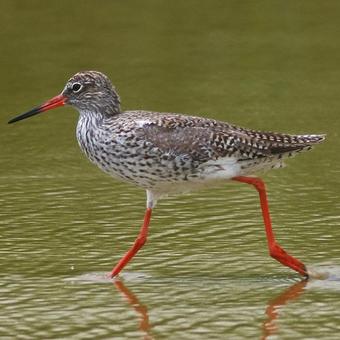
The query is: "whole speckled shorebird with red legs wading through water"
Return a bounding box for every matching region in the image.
[8,71,325,278]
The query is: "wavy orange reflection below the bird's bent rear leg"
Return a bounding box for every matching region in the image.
[262,279,307,340]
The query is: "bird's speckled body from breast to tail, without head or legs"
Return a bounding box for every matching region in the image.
[77,111,325,191]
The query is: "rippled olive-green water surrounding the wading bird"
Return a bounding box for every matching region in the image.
[0,0,340,339]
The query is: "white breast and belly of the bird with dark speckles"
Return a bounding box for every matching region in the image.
[77,116,198,189]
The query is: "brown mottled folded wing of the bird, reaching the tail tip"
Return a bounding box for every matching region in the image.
[137,115,324,162]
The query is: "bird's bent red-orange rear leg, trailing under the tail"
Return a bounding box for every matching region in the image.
[233,176,308,277]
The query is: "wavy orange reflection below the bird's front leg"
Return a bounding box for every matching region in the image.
[114,280,154,340]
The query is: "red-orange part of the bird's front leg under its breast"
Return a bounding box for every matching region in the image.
[110,208,152,277]
